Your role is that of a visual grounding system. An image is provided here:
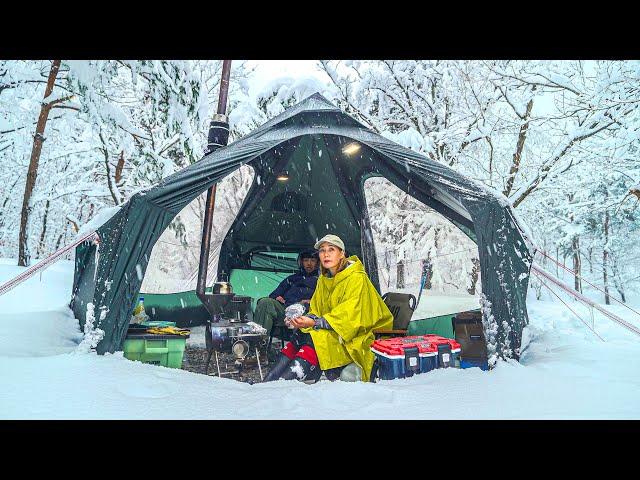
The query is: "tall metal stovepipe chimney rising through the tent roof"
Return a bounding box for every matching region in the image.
[196,60,231,314]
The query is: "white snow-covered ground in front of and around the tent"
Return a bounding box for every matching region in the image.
[0,260,640,419]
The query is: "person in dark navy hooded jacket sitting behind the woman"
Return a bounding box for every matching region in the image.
[253,250,318,333]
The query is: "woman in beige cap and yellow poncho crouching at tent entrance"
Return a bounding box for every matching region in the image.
[264,235,393,382]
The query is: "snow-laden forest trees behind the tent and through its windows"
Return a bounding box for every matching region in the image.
[0,60,640,303]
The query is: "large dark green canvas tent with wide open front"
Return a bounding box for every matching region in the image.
[71,94,531,359]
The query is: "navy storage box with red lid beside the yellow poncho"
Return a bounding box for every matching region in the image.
[371,335,460,380]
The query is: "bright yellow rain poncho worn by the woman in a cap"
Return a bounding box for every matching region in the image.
[301,255,393,382]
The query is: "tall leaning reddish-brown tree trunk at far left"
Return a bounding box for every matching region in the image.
[18,60,61,267]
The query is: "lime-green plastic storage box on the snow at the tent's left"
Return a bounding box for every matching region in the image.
[123,333,189,368]
